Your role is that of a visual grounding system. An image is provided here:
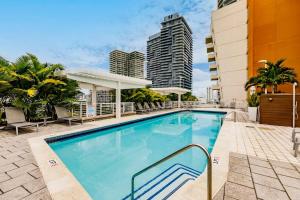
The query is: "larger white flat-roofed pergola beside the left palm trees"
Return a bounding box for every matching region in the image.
[67,70,152,118]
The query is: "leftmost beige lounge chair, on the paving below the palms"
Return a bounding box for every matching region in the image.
[4,107,39,135]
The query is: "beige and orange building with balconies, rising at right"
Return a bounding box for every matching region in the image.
[205,0,300,107]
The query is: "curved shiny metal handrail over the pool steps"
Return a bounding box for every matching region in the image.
[131,144,212,200]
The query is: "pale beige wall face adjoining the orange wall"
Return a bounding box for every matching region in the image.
[212,0,248,107]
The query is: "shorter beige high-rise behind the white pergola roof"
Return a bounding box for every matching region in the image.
[109,50,145,78]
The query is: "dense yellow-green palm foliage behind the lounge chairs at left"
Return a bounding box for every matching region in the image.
[0,54,79,119]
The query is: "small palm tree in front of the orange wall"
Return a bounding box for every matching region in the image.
[245,59,298,94]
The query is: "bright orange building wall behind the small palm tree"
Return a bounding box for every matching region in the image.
[248,0,300,92]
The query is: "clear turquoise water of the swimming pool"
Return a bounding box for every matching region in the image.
[49,112,224,200]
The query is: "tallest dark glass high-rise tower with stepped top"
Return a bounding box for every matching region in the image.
[147,13,193,89]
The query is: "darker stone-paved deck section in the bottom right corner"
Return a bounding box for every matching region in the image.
[214,153,300,200]
